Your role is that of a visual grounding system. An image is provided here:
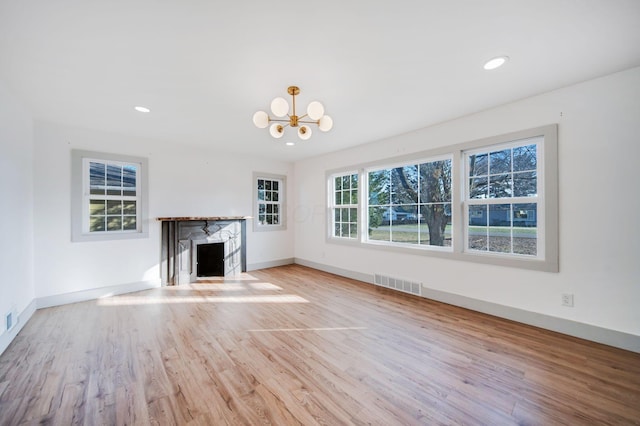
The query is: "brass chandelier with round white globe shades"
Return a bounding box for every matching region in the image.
[253,86,333,141]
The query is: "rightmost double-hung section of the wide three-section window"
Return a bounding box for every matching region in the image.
[464,137,544,257]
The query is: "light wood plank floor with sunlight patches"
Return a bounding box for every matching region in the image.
[0,266,640,425]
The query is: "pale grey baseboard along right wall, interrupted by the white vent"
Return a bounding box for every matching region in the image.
[295,258,640,353]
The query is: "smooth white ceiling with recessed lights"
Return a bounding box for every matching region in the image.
[0,0,640,161]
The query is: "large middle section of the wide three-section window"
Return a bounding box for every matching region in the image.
[367,159,451,247]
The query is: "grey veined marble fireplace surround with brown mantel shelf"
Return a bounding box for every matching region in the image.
[157,216,250,285]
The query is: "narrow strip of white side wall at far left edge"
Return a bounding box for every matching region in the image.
[0,81,35,353]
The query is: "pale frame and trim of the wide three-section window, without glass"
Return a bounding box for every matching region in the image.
[325,124,559,272]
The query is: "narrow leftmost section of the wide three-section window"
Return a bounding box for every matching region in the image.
[330,173,359,239]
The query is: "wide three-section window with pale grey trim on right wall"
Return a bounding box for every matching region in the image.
[327,125,558,271]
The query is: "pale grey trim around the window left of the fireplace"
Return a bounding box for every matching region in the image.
[71,149,149,242]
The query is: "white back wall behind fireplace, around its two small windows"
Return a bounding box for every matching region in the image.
[34,122,293,300]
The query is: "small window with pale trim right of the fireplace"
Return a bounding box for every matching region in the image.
[254,173,286,231]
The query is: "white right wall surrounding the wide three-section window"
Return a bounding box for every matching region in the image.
[295,68,640,351]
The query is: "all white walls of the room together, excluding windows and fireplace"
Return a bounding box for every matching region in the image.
[6,68,640,352]
